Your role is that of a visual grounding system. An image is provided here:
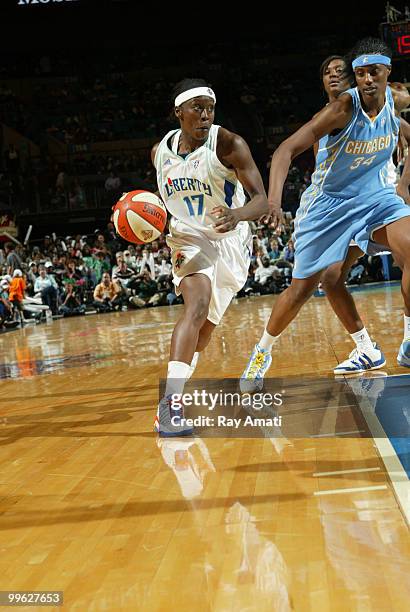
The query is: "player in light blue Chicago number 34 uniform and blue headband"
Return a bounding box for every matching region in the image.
[241,39,410,391]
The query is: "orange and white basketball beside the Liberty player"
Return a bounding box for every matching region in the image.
[112,190,167,244]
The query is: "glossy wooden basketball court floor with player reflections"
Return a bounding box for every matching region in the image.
[0,288,410,612]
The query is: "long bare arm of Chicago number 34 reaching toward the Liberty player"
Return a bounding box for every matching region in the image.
[268,94,352,226]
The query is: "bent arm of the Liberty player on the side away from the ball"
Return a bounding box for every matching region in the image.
[212,128,268,232]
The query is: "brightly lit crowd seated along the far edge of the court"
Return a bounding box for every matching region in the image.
[0,212,398,330]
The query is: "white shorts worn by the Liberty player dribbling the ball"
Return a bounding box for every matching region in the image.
[167,218,252,325]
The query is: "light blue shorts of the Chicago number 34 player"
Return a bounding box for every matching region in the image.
[293,185,410,278]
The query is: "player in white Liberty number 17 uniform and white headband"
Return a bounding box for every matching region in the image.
[152,79,268,436]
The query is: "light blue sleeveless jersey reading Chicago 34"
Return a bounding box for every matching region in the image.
[307,87,400,198]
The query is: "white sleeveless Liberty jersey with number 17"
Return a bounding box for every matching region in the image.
[154,125,246,240]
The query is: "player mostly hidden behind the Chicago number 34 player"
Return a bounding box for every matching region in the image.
[314,55,410,374]
